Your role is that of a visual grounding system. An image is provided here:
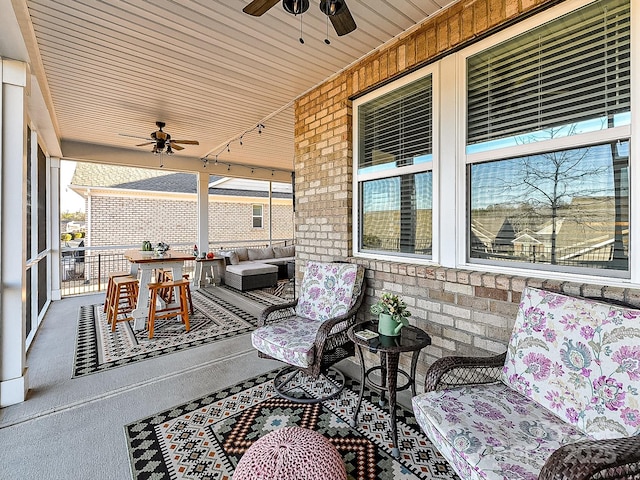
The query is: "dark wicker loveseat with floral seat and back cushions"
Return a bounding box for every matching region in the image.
[412,288,640,479]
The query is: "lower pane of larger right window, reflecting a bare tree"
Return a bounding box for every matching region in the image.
[469,141,629,271]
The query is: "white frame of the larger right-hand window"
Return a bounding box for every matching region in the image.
[456,0,640,286]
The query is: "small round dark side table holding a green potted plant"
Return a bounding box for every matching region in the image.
[347,322,431,458]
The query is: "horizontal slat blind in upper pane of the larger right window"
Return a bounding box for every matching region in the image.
[467,0,631,145]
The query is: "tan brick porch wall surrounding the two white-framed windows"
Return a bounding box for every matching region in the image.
[295,0,640,385]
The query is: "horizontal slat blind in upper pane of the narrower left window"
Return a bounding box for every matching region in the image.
[358,75,432,168]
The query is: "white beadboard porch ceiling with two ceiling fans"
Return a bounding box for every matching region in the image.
[20,0,451,170]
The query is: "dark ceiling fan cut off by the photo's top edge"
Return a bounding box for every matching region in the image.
[242,0,358,38]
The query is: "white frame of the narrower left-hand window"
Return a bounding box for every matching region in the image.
[352,65,440,265]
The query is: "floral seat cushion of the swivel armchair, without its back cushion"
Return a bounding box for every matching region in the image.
[251,317,322,368]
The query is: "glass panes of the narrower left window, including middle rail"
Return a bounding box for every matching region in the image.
[354,73,433,258]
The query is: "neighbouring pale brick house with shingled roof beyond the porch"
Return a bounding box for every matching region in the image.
[69,162,293,249]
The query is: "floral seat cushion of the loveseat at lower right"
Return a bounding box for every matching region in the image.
[412,382,588,480]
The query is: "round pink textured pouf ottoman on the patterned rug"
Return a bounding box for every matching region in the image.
[233,427,347,480]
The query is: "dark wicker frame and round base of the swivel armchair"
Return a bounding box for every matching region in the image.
[258,279,366,403]
